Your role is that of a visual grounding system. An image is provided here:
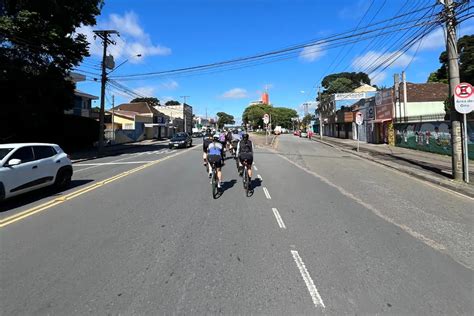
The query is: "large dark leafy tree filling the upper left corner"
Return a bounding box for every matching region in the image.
[0,0,103,143]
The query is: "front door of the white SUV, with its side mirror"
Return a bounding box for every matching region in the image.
[2,146,39,197]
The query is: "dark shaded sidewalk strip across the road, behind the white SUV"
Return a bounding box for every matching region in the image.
[69,139,169,163]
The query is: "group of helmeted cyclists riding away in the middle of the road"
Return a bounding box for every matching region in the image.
[202,129,253,189]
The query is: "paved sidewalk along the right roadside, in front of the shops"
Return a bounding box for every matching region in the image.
[312,135,474,197]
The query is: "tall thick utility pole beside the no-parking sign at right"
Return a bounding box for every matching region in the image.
[440,0,463,181]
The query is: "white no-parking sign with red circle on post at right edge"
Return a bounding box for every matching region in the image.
[454,82,474,183]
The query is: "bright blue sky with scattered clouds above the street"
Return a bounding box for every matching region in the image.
[78,0,474,119]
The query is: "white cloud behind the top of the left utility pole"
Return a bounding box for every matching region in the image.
[76,12,171,63]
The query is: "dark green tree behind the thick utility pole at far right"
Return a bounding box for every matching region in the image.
[428,35,474,83]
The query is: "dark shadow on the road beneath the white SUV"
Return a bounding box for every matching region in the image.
[0,180,93,213]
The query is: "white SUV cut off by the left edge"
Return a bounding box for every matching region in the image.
[0,143,72,201]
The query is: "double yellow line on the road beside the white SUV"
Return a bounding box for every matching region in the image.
[0,147,196,228]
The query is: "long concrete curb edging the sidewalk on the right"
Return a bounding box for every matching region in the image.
[312,139,474,198]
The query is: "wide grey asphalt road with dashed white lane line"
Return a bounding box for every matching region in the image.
[0,135,473,315]
